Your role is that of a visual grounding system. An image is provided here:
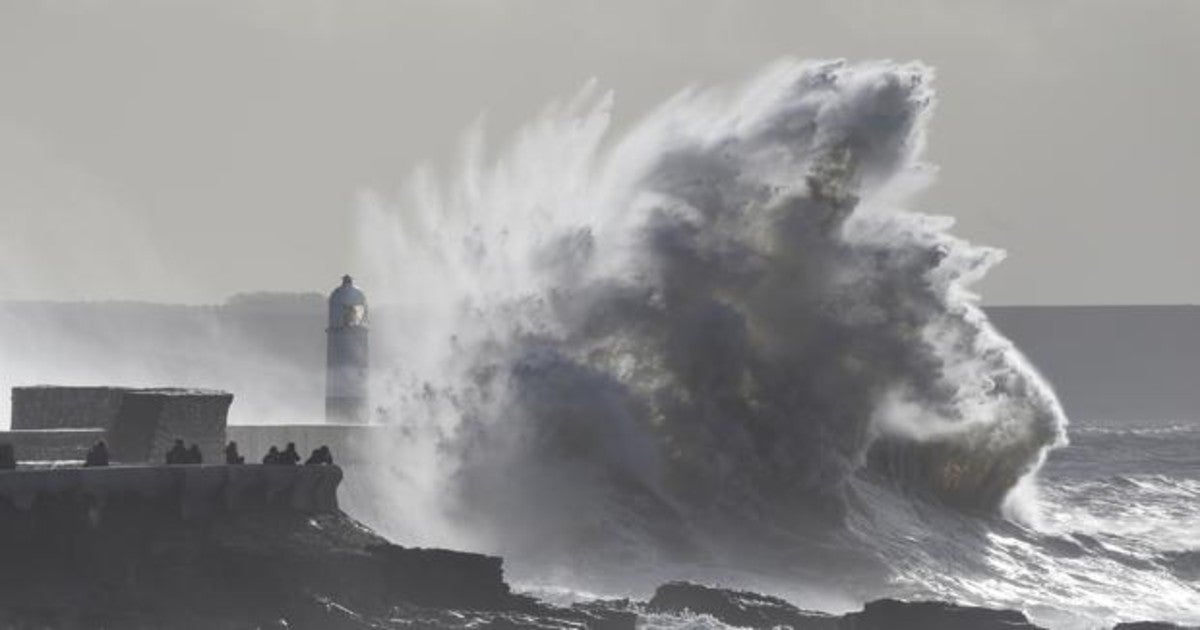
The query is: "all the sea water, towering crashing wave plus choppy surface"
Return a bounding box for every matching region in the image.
[350,60,1200,629]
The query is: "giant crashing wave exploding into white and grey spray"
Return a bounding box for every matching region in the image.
[364,61,1066,578]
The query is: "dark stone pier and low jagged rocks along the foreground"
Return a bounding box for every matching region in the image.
[0,466,1174,630]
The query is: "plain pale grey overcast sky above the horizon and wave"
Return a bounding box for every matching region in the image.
[0,0,1200,304]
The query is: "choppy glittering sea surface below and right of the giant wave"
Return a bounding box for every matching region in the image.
[518,420,1200,630]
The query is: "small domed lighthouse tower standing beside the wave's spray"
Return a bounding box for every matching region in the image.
[325,276,371,424]
